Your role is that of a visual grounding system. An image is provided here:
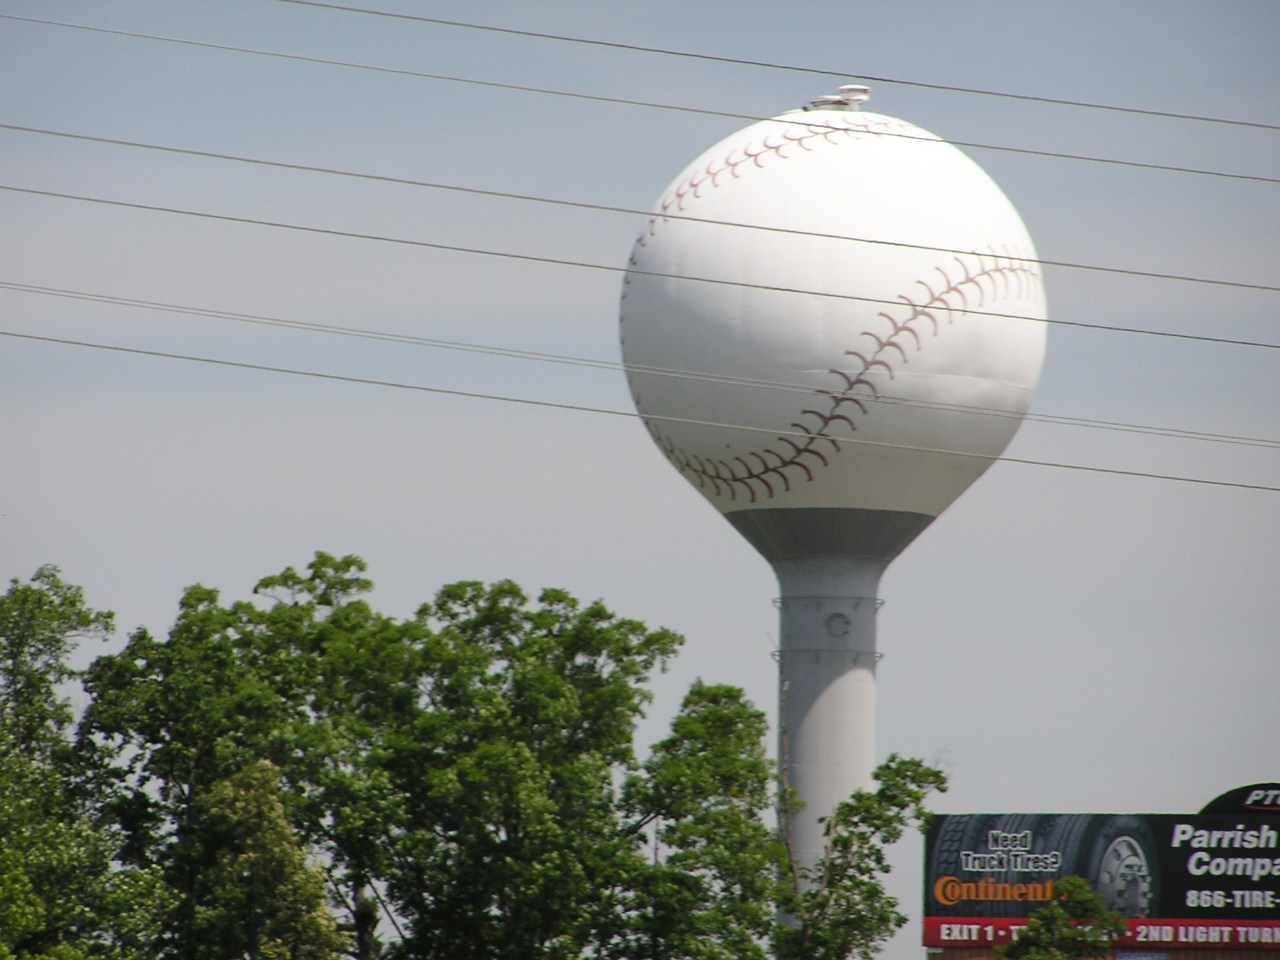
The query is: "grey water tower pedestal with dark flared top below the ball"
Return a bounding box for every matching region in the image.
[726,508,933,865]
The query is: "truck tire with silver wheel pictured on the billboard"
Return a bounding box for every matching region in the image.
[1079,817,1160,916]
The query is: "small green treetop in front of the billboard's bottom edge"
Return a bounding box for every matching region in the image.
[996,877,1126,960]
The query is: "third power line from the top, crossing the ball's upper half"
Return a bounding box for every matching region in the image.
[0,123,1280,293]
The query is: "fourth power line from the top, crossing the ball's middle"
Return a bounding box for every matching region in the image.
[0,184,1280,349]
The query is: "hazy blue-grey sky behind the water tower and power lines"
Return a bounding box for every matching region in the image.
[0,0,1280,959]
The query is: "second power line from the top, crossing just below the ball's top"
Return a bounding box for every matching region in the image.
[0,14,1280,183]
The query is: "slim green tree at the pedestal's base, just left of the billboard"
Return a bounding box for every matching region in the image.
[774,754,946,960]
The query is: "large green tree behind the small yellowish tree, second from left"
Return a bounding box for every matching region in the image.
[81,553,399,960]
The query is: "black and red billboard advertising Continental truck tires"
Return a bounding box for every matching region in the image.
[924,785,1280,960]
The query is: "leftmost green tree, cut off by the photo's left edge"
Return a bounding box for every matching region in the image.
[0,566,165,960]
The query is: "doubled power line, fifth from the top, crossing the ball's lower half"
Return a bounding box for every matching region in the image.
[0,280,1280,448]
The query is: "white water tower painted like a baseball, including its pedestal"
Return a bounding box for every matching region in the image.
[622,86,1046,864]
